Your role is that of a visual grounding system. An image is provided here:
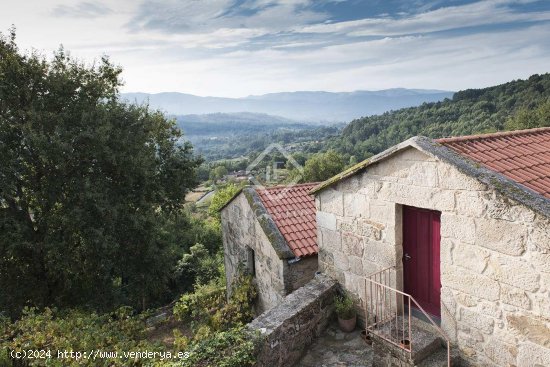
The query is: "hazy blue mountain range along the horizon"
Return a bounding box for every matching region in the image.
[122,88,453,122]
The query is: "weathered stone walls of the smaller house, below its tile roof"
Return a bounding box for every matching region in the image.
[221,189,317,313]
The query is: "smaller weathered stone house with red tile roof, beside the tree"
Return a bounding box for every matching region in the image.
[221,183,318,313]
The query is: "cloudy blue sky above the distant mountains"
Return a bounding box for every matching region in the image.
[0,0,550,97]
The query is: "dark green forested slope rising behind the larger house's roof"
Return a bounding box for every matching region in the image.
[327,74,550,158]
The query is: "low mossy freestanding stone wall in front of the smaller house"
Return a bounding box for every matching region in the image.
[248,274,336,367]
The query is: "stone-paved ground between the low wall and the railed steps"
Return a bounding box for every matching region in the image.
[296,323,372,367]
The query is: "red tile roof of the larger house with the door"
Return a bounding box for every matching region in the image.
[436,127,550,198]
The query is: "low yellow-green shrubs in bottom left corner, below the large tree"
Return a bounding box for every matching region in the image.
[0,308,163,367]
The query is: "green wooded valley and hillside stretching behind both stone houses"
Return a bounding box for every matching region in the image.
[199,74,550,187]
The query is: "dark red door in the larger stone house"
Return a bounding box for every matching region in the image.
[403,206,441,317]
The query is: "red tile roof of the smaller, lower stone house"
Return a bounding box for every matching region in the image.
[256,183,319,257]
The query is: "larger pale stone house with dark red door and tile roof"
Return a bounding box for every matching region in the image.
[311,128,550,366]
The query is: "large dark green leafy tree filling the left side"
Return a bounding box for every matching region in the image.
[0,32,200,314]
